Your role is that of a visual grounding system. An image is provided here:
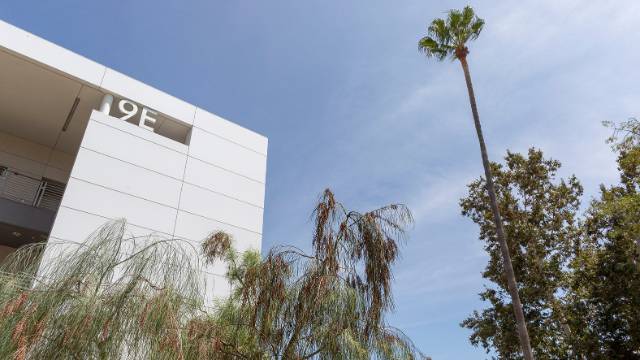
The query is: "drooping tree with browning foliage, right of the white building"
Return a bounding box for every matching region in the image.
[193,190,424,359]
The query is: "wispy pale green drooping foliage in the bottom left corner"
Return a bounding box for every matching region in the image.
[0,221,202,360]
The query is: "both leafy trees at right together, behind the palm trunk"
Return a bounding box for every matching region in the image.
[461,123,640,359]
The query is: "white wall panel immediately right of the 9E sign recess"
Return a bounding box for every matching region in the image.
[189,128,267,183]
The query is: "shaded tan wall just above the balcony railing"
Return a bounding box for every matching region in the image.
[0,130,74,183]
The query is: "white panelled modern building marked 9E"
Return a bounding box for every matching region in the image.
[0,21,267,296]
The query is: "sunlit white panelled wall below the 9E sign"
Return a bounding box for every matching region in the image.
[50,111,266,299]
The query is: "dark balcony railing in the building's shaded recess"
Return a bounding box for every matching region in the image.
[0,165,65,211]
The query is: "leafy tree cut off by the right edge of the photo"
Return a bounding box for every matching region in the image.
[570,119,640,359]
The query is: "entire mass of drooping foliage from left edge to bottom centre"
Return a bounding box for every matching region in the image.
[0,190,424,360]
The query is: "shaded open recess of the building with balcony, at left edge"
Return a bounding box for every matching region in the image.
[0,49,103,261]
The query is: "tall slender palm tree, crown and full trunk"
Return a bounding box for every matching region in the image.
[418,6,533,360]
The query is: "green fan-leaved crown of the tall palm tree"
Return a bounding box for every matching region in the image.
[418,6,484,61]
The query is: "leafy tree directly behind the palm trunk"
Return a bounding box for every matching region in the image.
[460,148,582,359]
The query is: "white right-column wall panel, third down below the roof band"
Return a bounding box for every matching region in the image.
[180,183,263,233]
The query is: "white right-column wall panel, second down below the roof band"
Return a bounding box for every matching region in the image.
[184,157,264,207]
